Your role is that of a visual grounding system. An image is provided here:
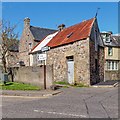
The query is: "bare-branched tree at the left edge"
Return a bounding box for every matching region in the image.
[0,22,18,73]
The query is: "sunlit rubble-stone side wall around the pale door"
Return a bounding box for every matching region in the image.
[47,39,90,85]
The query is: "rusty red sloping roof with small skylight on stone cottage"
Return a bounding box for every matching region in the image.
[47,18,95,47]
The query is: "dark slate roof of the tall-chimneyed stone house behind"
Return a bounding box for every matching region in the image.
[30,26,57,41]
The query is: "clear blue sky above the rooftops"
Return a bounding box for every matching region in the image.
[2,2,118,37]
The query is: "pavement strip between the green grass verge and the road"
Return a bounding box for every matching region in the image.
[0,89,62,97]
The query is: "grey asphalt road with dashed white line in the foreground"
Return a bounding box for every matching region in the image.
[2,88,118,118]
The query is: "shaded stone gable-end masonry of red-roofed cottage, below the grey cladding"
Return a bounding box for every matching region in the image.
[90,41,104,85]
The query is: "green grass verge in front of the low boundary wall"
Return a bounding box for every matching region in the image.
[0,82,40,90]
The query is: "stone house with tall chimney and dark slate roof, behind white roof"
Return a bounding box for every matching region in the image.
[19,17,56,66]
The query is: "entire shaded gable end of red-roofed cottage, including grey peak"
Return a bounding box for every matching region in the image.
[89,18,104,85]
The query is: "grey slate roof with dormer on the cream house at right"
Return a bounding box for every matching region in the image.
[104,35,120,47]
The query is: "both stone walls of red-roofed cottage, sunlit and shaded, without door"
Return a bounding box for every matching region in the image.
[47,39,104,85]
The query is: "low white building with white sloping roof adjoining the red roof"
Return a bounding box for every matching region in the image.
[30,32,58,66]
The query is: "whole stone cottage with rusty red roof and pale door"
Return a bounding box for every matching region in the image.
[30,18,104,85]
